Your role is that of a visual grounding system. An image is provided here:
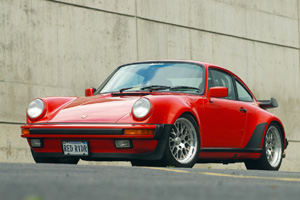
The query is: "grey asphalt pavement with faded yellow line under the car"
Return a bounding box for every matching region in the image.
[0,163,300,200]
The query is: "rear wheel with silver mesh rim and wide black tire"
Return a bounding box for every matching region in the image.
[245,123,283,171]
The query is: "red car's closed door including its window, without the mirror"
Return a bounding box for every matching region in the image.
[202,68,247,148]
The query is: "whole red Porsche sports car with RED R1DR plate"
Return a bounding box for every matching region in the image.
[21,60,288,170]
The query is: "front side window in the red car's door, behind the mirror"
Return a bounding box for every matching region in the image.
[208,70,236,100]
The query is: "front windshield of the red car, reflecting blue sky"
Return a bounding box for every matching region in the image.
[96,62,205,94]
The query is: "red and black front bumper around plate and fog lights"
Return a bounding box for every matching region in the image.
[21,124,172,161]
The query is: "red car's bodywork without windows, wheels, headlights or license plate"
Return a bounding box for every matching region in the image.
[21,61,287,170]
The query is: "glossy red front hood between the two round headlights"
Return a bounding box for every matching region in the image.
[49,95,141,123]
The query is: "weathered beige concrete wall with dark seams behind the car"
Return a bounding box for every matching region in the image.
[0,0,300,171]
